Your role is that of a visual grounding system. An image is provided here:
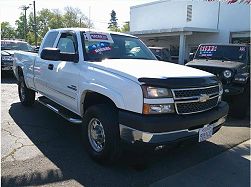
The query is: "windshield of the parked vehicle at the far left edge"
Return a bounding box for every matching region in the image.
[1,41,32,51]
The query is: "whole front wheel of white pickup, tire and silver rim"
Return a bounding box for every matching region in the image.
[82,104,121,163]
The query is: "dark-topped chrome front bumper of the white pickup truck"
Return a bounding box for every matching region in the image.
[119,102,228,144]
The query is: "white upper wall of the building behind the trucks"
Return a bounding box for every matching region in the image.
[130,0,250,61]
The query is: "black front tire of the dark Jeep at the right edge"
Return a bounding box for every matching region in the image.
[230,88,250,118]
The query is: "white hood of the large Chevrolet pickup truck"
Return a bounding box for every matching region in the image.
[89,59,214,82]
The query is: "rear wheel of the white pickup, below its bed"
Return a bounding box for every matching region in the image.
[18,76,36,106]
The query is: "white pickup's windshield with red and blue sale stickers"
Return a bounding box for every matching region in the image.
[82,32,156,61]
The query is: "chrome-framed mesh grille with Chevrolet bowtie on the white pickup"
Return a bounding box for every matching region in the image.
[172,85,219,114]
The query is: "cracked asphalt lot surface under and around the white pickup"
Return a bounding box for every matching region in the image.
[1,77,250,186]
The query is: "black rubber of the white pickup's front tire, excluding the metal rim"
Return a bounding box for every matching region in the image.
[82,104,122,164]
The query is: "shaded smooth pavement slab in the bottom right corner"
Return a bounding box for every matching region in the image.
[150,140,250,187]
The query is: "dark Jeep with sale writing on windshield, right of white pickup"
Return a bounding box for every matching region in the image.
[186,44,250,117]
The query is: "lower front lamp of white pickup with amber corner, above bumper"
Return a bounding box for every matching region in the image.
[143,103,175,114]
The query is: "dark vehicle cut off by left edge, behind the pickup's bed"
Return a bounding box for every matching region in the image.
[1,40,34,71]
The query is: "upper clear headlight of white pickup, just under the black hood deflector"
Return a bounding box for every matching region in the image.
[142,86,172,99]
